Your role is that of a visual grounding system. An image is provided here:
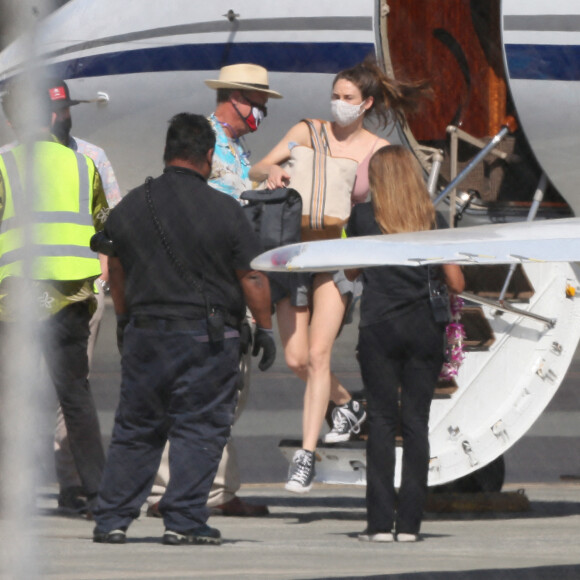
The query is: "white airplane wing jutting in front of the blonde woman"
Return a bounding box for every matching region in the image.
[252,218,580,272]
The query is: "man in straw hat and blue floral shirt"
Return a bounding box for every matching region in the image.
[147,63,282,517]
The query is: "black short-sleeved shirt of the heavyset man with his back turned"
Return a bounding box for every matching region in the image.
[105,167,261,319]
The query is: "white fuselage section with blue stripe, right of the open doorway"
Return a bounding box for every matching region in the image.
[502,0,580,216]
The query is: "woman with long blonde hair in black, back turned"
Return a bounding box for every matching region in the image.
[347,146,464,542]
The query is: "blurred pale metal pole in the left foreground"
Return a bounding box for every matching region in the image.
[0,0,55,580]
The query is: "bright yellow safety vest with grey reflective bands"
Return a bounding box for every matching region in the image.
[0,141,101,282]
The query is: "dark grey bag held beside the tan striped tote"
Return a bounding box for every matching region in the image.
[240,187,302,250]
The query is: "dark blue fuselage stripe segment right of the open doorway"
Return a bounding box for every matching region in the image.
[505,44,580,81]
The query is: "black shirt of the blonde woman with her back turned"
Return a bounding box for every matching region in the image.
[346,202,429,326]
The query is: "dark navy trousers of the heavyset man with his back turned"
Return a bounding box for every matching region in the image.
[94,319,240,532]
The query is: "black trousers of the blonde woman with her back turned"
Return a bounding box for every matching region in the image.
[358,301,445,534]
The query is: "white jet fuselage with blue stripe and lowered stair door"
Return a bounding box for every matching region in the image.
[0,0,580,484]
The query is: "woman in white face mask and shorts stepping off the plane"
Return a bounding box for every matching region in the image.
[250,61,427,493]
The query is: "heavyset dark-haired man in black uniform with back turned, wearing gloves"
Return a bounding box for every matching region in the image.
[93,113,276,544]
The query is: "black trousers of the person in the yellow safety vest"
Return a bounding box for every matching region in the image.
[0,300,105,497]
